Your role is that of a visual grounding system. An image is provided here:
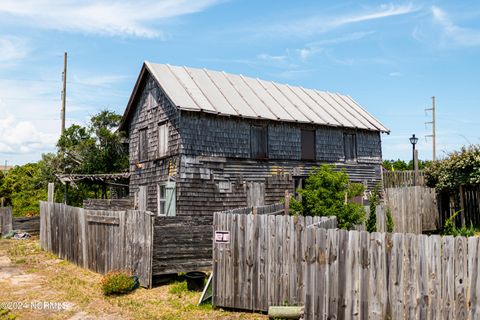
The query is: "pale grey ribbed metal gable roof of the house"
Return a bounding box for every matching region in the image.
[120,61,390,133]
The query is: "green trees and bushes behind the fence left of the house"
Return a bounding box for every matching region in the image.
[0,110,129,215]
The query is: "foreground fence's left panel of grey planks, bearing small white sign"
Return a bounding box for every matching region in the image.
[212,213,337,311]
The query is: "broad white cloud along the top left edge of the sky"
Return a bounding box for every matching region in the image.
[0,0,220,37]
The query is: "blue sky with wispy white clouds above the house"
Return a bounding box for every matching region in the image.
[0,0,480,165]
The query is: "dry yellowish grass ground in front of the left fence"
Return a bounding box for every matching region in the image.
[0,239,266,319]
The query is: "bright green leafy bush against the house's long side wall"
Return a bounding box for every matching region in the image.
[290,165,365,229]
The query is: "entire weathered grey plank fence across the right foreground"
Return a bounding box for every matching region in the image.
[213,213,480,319]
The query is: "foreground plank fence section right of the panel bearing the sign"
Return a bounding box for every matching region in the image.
[304,229,480,319]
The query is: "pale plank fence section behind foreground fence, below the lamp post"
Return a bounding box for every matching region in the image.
[384,186,439,234]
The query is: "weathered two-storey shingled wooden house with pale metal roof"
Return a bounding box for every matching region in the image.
[120,62,389,216]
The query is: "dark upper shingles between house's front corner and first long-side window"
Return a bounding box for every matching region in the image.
[181,112,250,158]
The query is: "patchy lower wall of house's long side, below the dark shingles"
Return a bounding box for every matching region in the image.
[177,156,381,215]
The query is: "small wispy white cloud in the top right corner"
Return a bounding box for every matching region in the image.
[432,6,480,47]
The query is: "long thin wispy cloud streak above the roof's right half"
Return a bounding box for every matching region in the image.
[265,4,418,36]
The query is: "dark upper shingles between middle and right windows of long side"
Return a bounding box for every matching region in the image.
[315,127,345,162]
